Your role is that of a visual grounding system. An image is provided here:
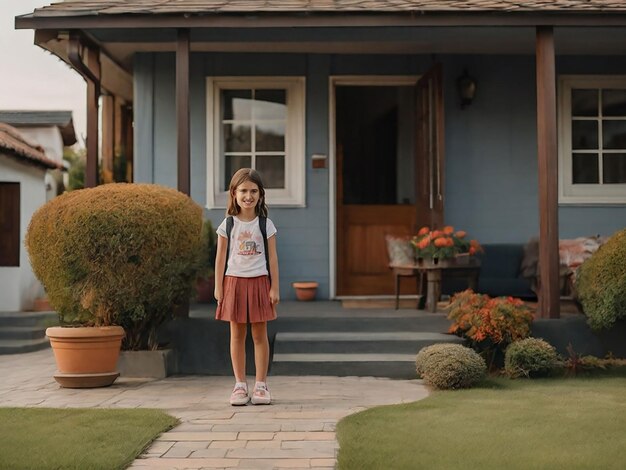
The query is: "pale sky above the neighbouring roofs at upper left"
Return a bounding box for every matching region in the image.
[0,0,87,147]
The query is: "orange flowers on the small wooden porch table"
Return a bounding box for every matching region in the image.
[411,225,483,259]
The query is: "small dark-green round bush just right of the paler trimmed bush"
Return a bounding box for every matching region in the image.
[504,338,559,378]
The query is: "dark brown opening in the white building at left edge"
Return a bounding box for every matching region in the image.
[0,183,20,266]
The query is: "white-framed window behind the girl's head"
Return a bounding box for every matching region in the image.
[207,77,305,209]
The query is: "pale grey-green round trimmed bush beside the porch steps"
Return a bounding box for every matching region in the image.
[415,343,487,390]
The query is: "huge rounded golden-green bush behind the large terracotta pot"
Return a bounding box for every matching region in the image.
[26,183,202,349]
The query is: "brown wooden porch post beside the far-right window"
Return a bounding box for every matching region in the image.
[536,26,560,318]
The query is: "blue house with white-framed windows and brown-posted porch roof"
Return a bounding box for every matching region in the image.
[16,0,626,317]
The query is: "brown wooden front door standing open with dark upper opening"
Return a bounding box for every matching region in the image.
[335,70,443,296]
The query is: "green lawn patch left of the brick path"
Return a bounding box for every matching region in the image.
[0,408,178,470]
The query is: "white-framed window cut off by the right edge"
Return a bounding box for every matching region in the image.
[559,76,626,204]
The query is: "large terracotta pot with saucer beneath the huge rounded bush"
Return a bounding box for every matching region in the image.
[46,326,124,388]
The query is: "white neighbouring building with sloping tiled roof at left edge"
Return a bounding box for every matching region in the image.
[0,122,63,311]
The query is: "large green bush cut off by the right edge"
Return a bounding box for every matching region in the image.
[576,229,626,330]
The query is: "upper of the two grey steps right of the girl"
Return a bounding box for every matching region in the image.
[274,331,462,354]
